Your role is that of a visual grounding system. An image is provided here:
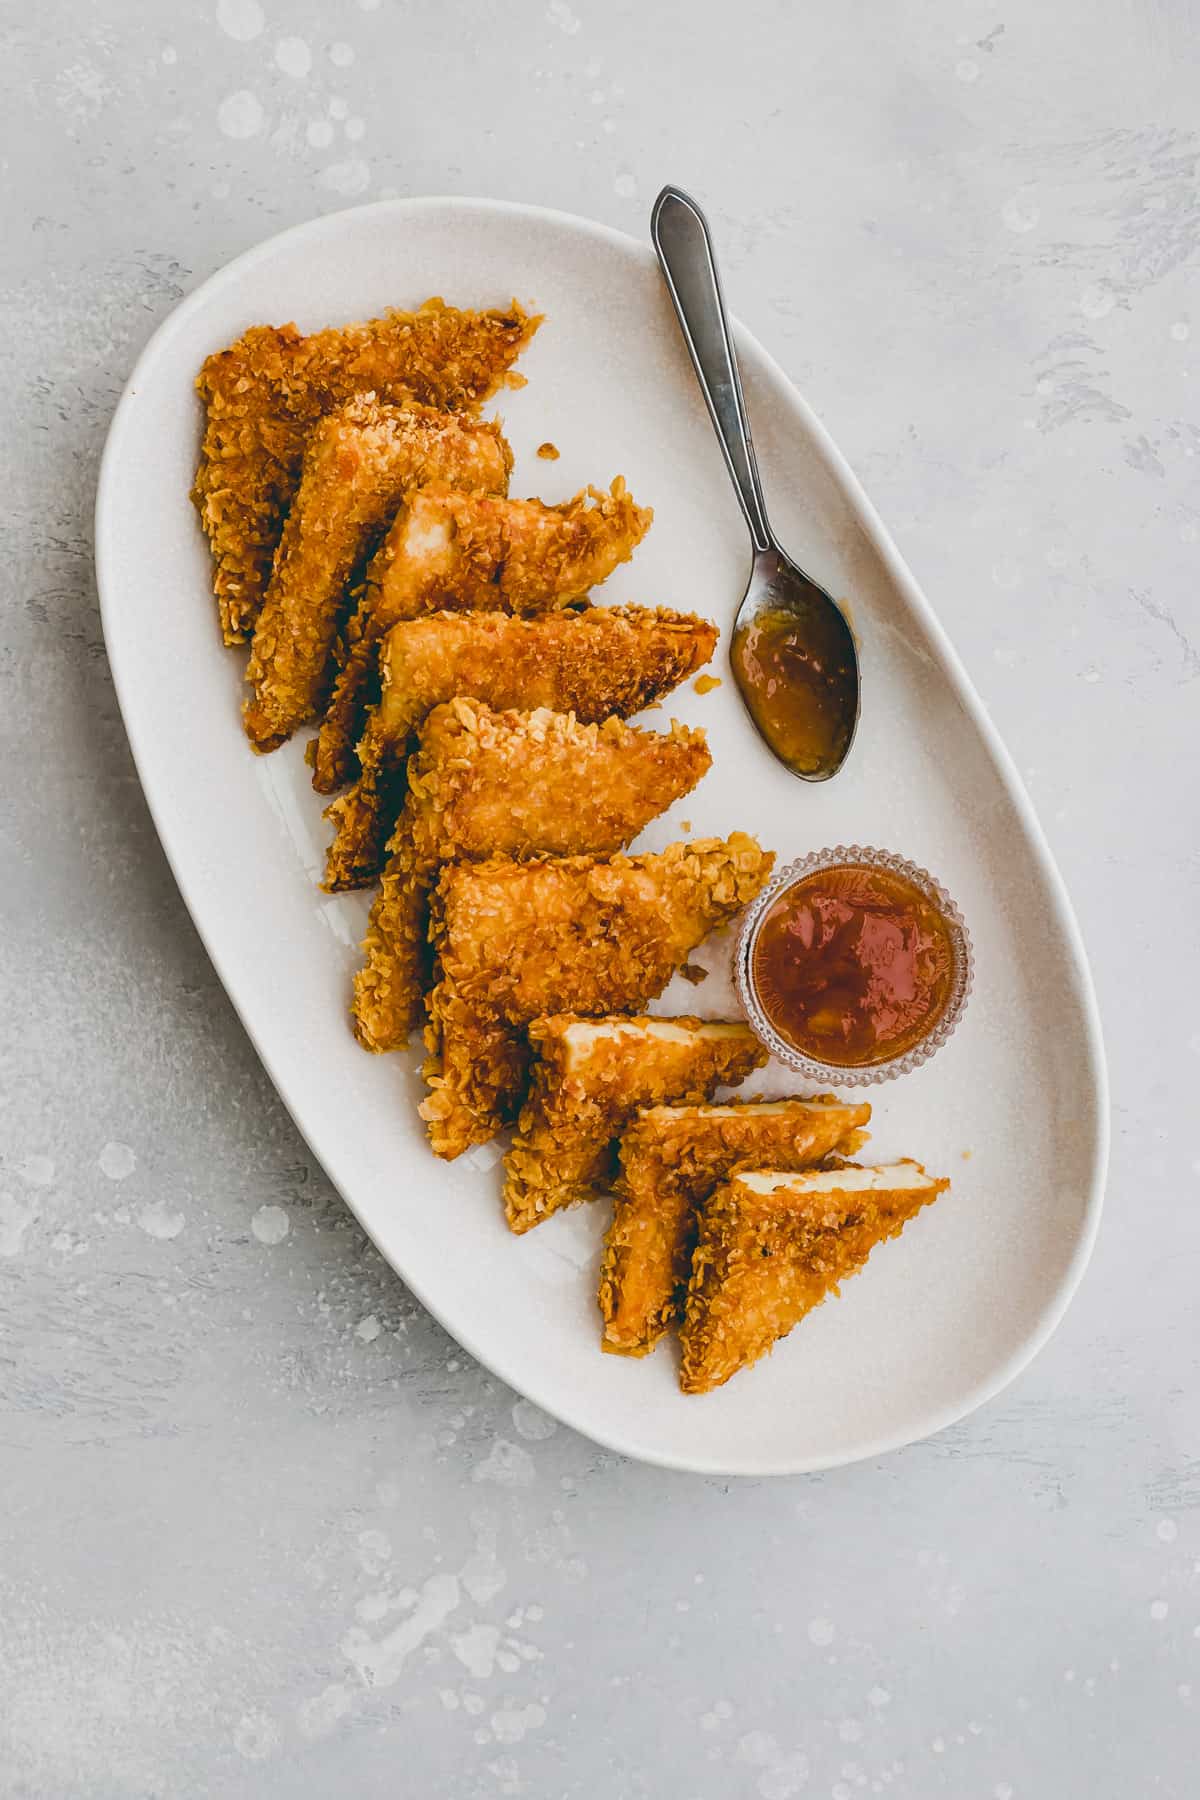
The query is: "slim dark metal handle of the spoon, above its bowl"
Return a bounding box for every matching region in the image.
[649,187,774,551]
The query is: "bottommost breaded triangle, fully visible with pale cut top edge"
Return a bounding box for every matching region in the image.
[680,1161,950,1393]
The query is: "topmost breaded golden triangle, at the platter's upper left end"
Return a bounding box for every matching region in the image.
[193,301,542,644]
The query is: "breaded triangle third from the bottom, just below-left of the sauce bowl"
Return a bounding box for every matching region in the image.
[504,1013,766,1231]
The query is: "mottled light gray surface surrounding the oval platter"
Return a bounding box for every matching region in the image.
[0,0,1200,1800]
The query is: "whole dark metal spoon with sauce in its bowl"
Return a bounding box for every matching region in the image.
[649,187,858,781]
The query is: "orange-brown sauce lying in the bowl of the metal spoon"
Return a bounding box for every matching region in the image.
[730,603,856,774]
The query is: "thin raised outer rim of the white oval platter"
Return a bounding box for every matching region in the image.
[94,194,1112,1480]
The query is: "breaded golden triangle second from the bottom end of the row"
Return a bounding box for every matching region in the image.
[599,1094,871,1355]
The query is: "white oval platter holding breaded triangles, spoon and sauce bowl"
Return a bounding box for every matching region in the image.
[97,200,1108,1474]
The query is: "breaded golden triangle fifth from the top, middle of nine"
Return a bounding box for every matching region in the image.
[354,700,712,1051]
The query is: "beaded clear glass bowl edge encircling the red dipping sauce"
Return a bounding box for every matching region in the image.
[734,844,975,1087]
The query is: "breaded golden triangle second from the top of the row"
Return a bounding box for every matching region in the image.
[245,394,513,751]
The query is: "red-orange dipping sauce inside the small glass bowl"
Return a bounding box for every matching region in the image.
[750,866,957,1069]
